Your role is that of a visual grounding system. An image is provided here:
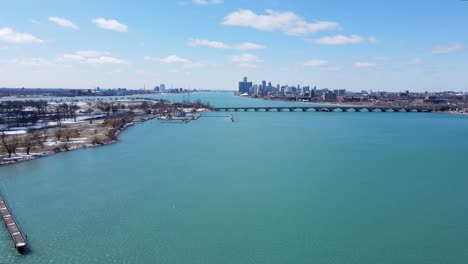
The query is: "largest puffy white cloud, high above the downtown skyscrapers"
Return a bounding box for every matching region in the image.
[223,9,340,36]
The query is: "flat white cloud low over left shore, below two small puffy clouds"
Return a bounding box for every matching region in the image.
[59,50,128,64]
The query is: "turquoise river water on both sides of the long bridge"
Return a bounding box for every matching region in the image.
[0,94,468,264]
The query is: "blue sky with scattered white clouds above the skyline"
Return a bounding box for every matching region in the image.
[0,0,468,92]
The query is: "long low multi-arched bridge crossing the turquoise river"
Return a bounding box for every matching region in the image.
[213,106,433,113]
